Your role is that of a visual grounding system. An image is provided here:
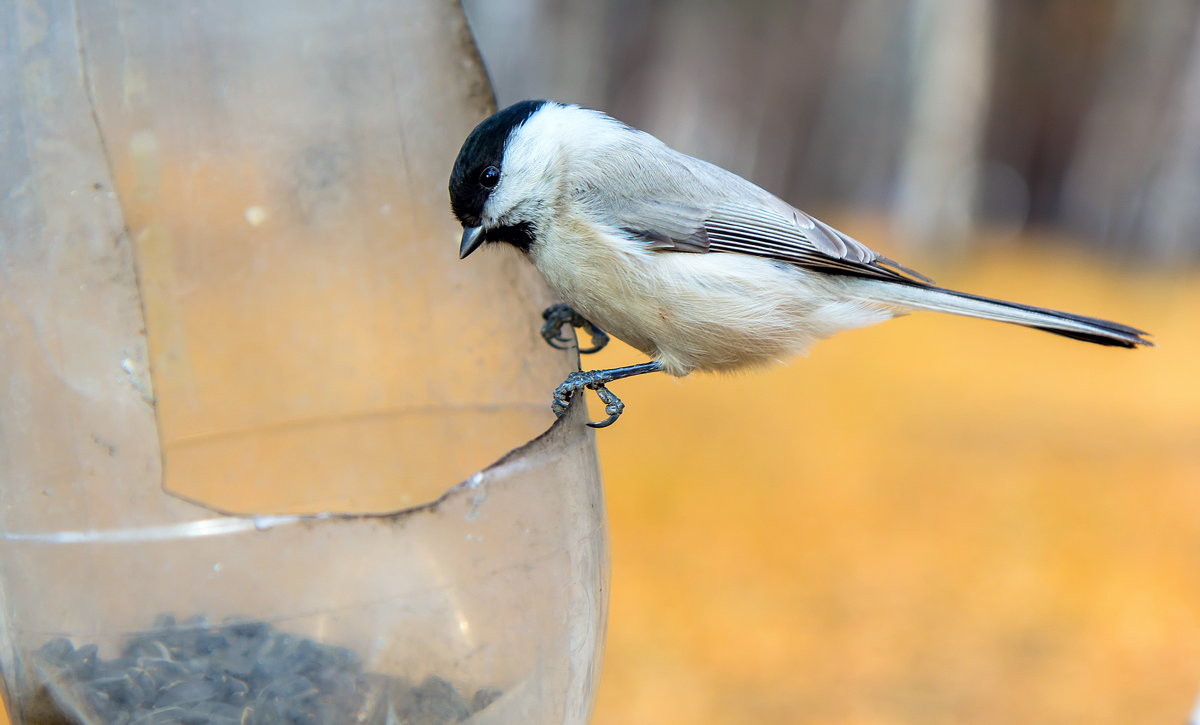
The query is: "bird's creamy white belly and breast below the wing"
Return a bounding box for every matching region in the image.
[530,223,895,376]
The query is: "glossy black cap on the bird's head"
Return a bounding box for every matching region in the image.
[450,101,548,227]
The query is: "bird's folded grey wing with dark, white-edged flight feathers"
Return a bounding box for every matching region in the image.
[614,195,932,283]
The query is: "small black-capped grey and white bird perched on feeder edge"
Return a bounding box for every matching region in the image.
[450,101,1151,427]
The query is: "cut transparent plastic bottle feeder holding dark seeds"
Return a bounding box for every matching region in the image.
[0,0,608,725]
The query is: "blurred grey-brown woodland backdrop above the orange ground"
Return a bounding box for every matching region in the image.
[466,0,1200,260]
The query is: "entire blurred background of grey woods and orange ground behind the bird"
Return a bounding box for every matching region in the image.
[464,0,1200,725]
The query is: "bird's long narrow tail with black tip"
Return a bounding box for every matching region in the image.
[862,280,1153,347]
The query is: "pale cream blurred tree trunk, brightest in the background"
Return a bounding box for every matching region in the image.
[895,0,991,252]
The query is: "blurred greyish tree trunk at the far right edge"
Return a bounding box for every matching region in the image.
[1063,0,1200,259]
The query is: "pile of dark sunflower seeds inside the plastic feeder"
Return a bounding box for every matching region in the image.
[29,617,499,725]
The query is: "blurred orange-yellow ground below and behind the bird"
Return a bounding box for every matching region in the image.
[586,231,1200,725]
